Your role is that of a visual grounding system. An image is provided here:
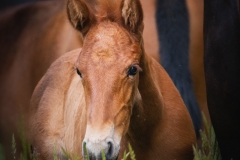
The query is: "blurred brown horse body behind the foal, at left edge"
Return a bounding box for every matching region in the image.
[0,1,82,159]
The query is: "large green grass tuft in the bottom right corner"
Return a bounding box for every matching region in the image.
[193,114,222,160]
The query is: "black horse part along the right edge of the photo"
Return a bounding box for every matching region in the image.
[204,0,240,160]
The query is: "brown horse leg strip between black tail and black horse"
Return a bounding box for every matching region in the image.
[186,0,211,123]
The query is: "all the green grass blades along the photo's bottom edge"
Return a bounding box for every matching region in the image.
[0,115,222,160]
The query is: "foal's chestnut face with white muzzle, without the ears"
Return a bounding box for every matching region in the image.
[76,22,141,159]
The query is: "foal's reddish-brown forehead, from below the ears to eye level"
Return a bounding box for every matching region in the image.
[78,22,141,72]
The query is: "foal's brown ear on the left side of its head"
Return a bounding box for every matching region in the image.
[67,0,96,36]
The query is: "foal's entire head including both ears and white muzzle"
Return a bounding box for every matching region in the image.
[68,0,143,159]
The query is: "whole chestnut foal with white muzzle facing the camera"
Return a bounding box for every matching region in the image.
[30,0,195,160]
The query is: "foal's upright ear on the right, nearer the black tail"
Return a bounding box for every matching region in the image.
[121,0,143,34]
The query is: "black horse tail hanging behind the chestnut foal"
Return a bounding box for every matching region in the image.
[156,0,202,136]
